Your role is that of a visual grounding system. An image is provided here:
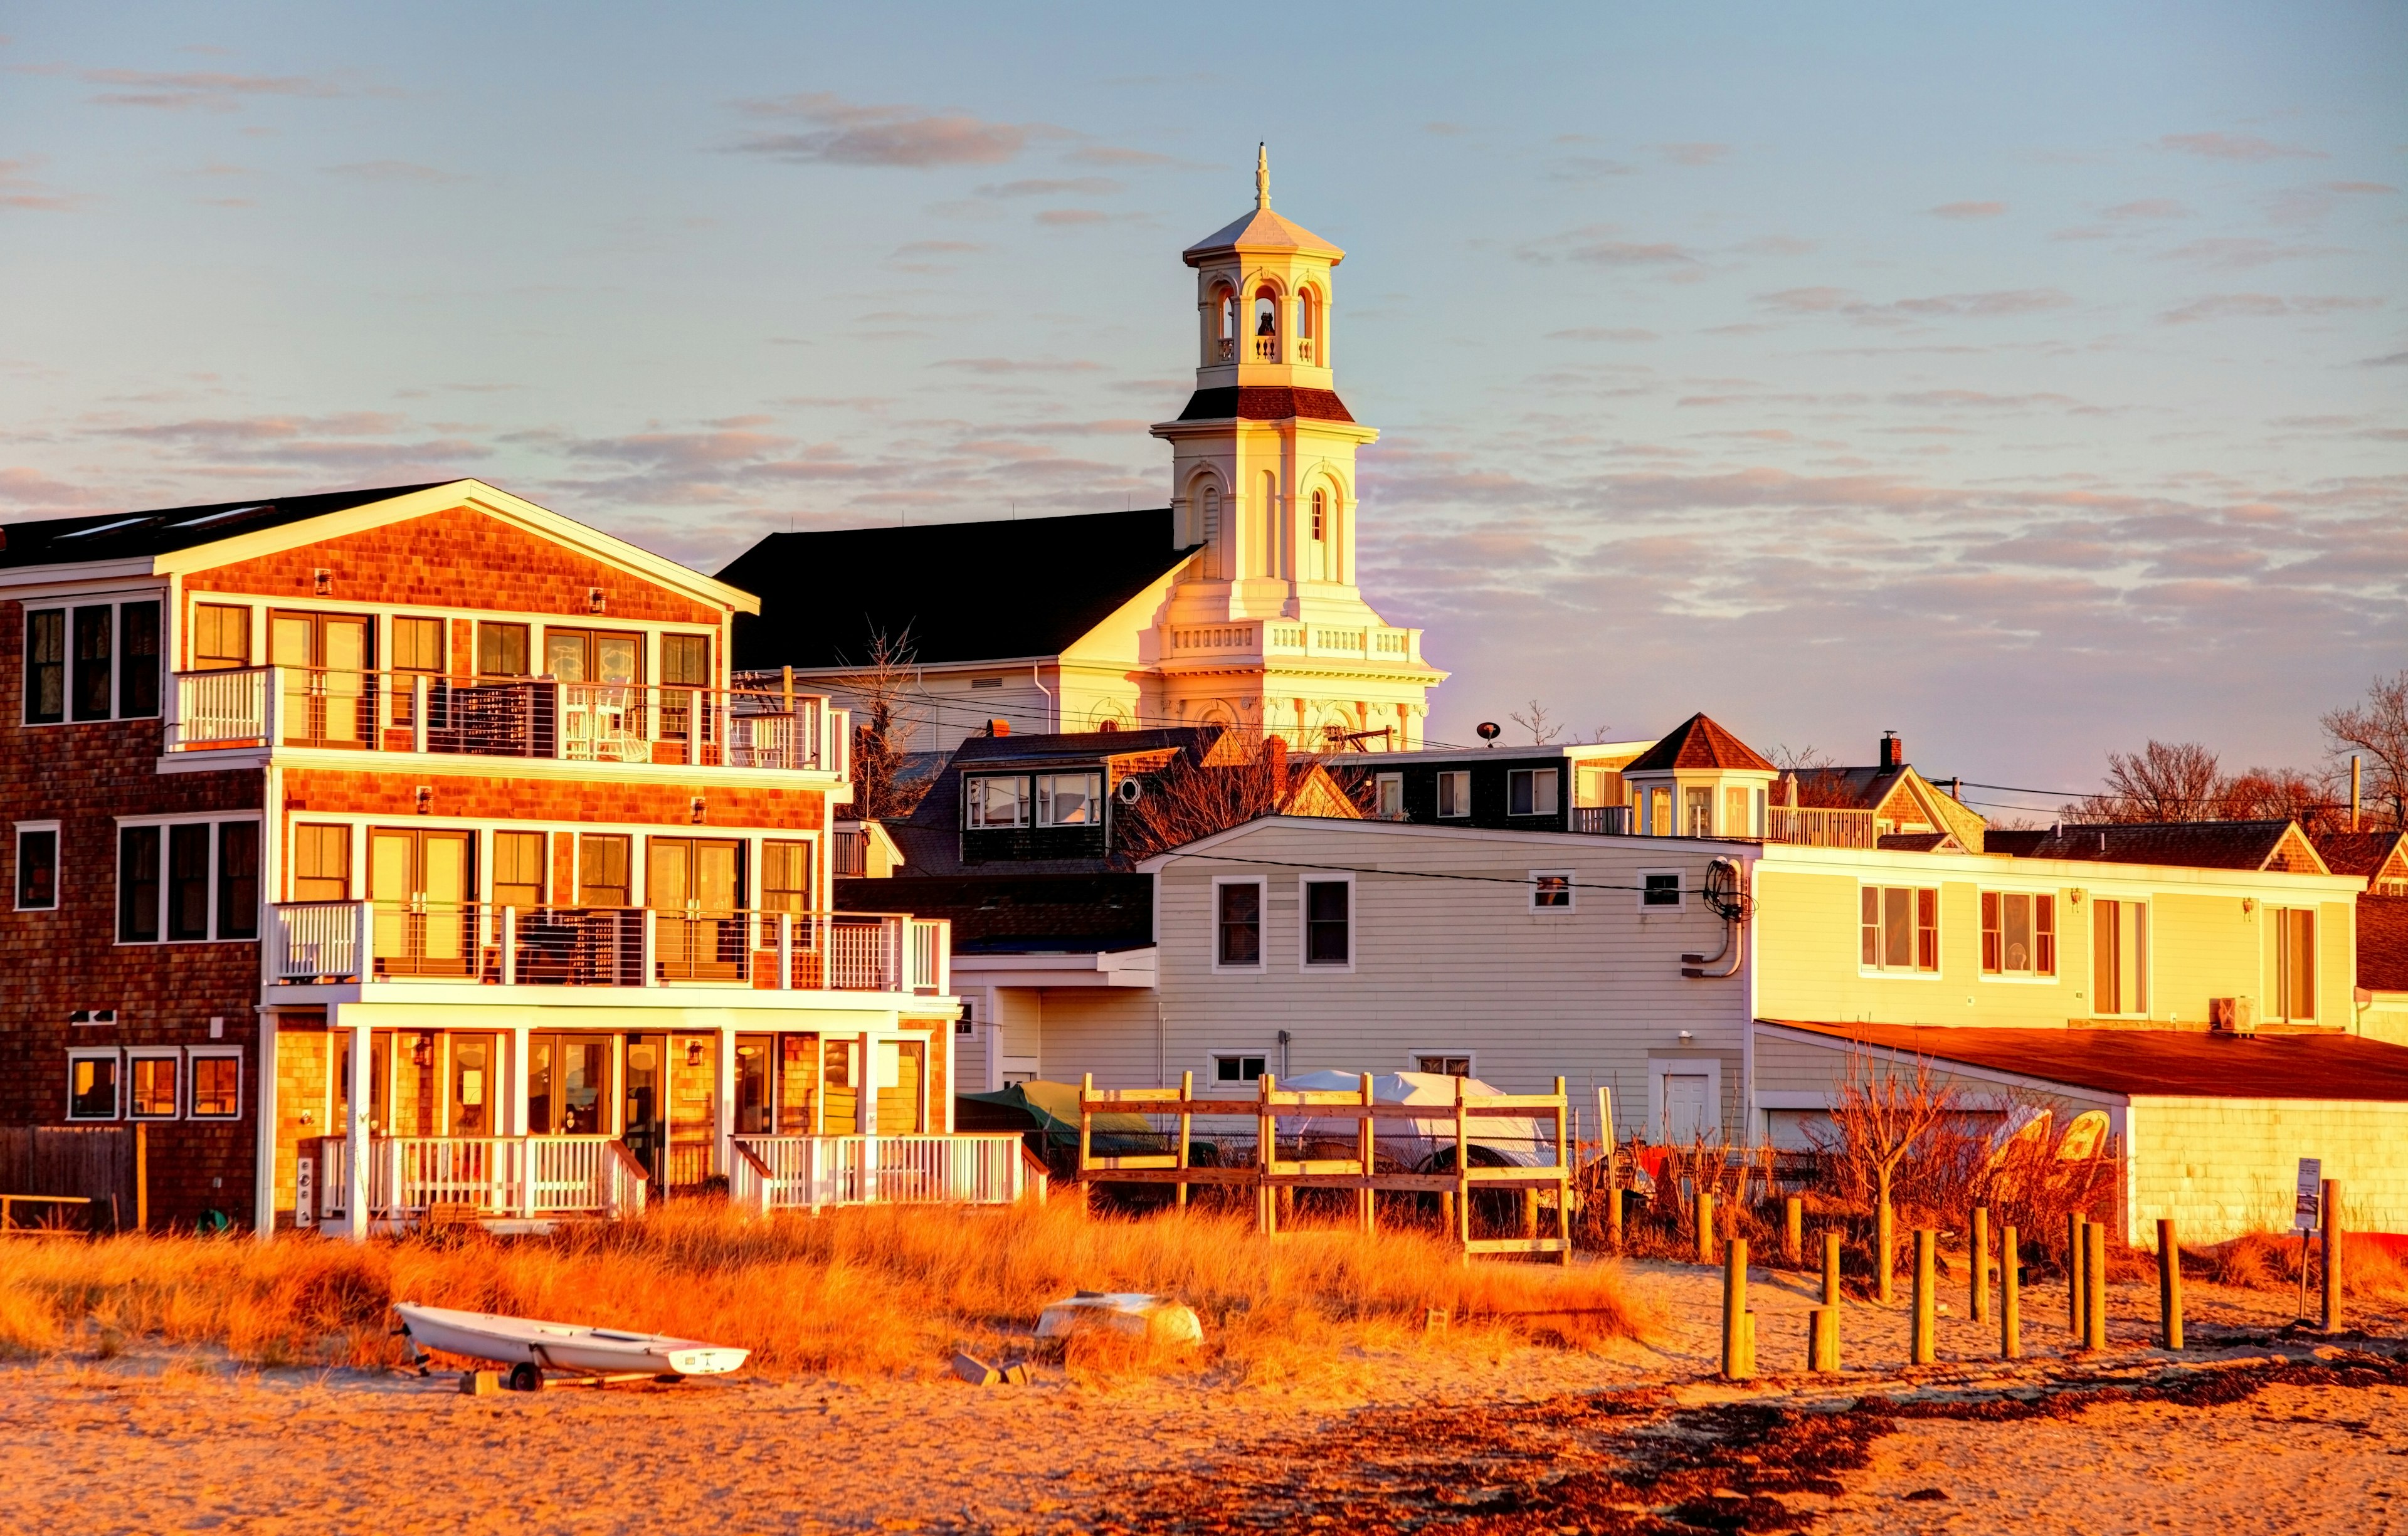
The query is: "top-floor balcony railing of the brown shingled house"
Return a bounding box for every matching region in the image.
[166,667,852,773]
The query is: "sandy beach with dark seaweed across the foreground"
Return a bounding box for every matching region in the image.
[0,1264,2408,1536]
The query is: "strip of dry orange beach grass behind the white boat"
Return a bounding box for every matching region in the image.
[0,1201,1642,1382]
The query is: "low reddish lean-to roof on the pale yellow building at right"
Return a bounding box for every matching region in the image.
[1760,1018,2408,1103]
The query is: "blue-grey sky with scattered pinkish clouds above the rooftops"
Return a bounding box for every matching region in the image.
[0,3,2408,804]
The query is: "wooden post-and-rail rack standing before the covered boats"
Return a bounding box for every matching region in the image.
[1079,1071,1573,1264]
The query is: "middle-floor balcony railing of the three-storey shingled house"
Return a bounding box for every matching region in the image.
[267,900,954,997]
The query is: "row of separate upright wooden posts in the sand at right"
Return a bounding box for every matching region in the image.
[1698,1180,2340,1382]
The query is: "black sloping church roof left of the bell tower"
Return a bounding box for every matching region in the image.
[717,508,1196,671]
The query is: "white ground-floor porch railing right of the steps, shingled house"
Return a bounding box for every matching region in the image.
[727,1134,1043,1216]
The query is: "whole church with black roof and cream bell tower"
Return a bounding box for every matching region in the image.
[720,157,1447,751]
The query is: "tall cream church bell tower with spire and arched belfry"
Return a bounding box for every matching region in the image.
[1153,147,1447,751]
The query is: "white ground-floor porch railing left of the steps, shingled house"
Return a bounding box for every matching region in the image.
[318,1137,645,1221]
